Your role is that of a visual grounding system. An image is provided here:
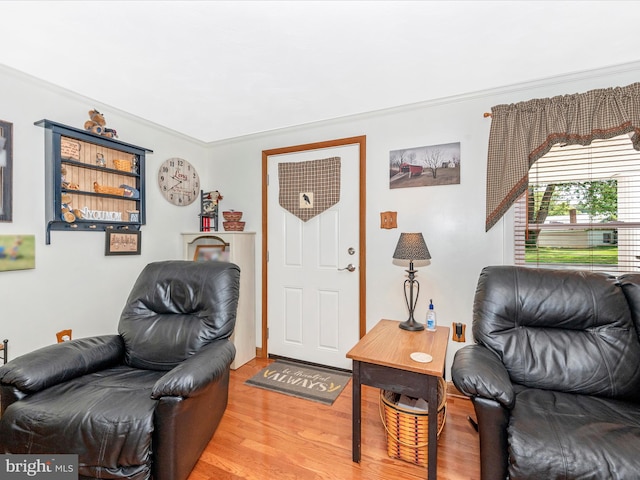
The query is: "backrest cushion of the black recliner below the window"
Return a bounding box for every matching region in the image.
[473,265,640,400]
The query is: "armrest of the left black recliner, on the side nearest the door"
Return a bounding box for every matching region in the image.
[151,339,236,399]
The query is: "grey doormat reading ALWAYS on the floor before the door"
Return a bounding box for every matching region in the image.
[245,360,351,405]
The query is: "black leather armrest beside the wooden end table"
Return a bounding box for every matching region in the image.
[451,345,515,408]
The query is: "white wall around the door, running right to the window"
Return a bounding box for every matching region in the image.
[206,63,640,376]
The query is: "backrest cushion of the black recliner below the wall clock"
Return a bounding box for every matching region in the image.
[118,260,240,370]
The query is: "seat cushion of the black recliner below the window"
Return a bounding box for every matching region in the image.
[508,389,640,480]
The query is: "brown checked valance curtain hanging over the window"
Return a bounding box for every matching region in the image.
[485,83,640,231]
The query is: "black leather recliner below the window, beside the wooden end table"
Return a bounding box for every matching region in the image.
[451,266,640,480]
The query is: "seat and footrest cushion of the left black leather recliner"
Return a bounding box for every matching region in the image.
[0,366,164,480]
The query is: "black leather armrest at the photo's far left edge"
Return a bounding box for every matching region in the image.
[0,335,124,393]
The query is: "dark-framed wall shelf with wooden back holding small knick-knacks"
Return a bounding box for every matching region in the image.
[35,120,152,245]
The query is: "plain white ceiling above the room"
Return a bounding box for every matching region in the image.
[0,0,640,142]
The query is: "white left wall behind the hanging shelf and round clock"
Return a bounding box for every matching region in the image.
[0,62,209,358]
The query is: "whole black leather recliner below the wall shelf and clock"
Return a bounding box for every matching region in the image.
[0,261,240,480]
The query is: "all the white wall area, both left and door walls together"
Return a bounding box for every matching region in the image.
[0,62,640,376]
